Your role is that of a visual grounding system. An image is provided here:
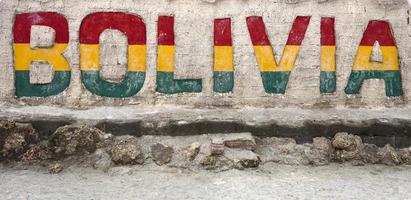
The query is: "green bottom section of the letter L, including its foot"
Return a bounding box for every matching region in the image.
[156,72,203,94]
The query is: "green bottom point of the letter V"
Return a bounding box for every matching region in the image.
[261,72,291,94]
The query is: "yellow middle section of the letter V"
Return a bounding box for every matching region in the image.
[254,45,300,72]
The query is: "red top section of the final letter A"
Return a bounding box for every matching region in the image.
[360,20,396,46]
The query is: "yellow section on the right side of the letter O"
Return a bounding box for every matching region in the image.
[128,45,147,72]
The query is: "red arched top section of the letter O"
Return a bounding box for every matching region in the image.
[80,12,146,45]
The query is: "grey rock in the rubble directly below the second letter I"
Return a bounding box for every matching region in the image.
[305,137,334,166]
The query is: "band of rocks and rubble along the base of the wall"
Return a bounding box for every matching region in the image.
[0,121,411,173]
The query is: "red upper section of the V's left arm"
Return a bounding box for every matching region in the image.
[246,16,271,45]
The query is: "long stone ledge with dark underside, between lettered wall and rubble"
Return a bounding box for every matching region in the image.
[0,105,411,147]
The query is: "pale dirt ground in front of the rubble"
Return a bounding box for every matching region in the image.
[0,164,411,200]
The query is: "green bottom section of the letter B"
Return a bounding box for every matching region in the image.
[15,71,71,97]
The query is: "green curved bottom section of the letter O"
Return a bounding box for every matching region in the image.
[81,71,146,98]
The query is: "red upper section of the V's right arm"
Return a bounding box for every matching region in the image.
[287,16,311,45]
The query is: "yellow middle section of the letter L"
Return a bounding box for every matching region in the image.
[157,45,174,72]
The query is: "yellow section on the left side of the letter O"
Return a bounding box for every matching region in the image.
[80,44,100,71]
